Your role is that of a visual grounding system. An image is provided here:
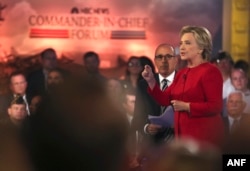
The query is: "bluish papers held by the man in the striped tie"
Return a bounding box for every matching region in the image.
[148,105,174,127]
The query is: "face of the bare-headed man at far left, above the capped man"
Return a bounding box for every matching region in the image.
[10,74,27,95]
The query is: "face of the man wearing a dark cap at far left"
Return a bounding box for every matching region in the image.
[8,104,27,120]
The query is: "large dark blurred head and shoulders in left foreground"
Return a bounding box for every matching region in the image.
[24,76,128,171]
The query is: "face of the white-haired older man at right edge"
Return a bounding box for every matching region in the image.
[227,93,246,118]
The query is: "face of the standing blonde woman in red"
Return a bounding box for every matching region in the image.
[180,33,202,60]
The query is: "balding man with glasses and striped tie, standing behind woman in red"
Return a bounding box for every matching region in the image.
[133,44,178,144]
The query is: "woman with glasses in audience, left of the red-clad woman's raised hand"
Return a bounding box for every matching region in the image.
[121,56,143,91]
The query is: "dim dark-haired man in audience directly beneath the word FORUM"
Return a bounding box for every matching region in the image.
[83,51,106,82]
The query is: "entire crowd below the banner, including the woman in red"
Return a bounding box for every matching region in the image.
[0,26,250,171]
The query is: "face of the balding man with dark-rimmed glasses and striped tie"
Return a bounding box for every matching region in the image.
[154,46,178,77]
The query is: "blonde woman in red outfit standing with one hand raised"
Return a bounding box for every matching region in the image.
[142,26,224,147]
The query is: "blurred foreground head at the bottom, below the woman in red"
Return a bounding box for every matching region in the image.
[144,139,222,171]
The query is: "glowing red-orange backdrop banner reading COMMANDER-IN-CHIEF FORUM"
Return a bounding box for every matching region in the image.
[0,0,222,68]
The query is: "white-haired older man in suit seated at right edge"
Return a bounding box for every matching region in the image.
[224,90,246,135]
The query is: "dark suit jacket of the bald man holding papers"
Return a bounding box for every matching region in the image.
[132,74,175,143]
